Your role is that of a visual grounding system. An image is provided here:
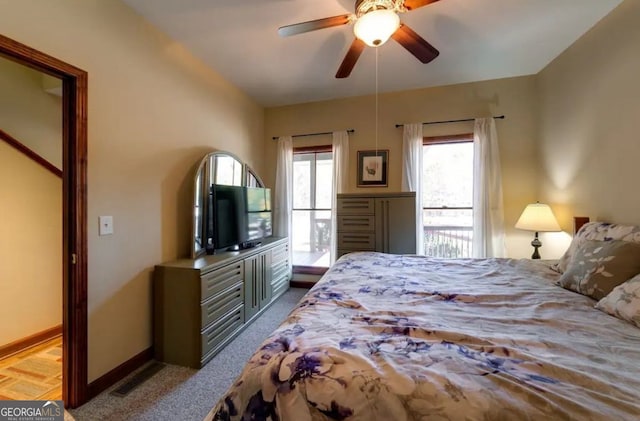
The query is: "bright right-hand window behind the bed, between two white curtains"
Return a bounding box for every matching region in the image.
[422,133,473,258]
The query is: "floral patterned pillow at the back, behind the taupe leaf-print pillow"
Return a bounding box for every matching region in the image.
[551,222,640,273]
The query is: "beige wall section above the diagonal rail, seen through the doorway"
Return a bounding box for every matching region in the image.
[0,57,62,169]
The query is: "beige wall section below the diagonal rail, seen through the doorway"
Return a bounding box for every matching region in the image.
[0,140,62,346]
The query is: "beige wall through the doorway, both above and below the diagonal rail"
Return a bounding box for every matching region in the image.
[0,51,62,345]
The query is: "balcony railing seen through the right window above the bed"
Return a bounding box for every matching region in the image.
[424,225,473,258]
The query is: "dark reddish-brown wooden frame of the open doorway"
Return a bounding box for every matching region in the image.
[0,35,88,408]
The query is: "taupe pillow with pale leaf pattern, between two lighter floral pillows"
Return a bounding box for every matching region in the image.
[558,240,640,300]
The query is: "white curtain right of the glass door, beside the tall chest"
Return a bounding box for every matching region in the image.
[331,131,349,264]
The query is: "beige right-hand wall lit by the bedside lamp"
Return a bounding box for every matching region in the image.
[537,0,640,256]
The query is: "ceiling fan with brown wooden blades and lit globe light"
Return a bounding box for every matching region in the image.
[278,0,440,78]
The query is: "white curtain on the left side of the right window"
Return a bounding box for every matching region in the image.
[402,123,424,254]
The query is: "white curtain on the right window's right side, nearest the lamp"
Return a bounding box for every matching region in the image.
[473,118,507,257]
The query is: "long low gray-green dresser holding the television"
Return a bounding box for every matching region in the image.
[153,237,291,368]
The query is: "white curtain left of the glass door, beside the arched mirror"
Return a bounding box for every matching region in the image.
[273,136,293,251]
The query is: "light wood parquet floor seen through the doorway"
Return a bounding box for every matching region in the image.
[0,336,62,400]
